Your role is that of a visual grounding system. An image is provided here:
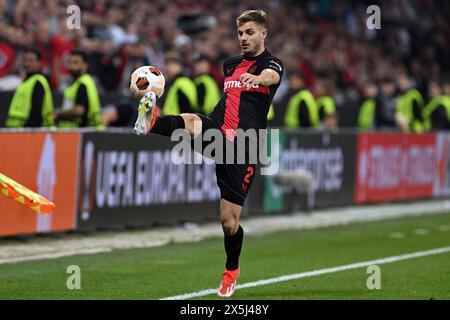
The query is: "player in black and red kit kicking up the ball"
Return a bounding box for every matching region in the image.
[135,10,283,297]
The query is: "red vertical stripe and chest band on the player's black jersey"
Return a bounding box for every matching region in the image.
[220,60,269,141]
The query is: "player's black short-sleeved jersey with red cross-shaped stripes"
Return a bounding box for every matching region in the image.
[208,50,284,140]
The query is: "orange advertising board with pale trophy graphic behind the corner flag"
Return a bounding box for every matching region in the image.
[0,132,80,236]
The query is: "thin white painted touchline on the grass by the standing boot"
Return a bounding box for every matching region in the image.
[160,247,450,300]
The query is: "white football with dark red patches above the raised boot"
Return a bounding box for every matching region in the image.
[130,66,166,100]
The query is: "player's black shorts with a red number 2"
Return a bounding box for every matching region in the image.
[196,114,256,206]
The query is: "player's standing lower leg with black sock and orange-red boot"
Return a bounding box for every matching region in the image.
[217,199,244,297]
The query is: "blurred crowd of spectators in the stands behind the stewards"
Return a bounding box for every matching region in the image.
[0,0,450,131]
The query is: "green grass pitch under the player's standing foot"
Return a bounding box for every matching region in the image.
[0,213,450,299]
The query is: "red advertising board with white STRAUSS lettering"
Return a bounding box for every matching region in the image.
[355,133,437,203]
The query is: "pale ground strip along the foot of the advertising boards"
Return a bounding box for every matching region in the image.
[0,200,450,265]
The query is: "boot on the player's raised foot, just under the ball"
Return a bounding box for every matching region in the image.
[134,92,159,136]
